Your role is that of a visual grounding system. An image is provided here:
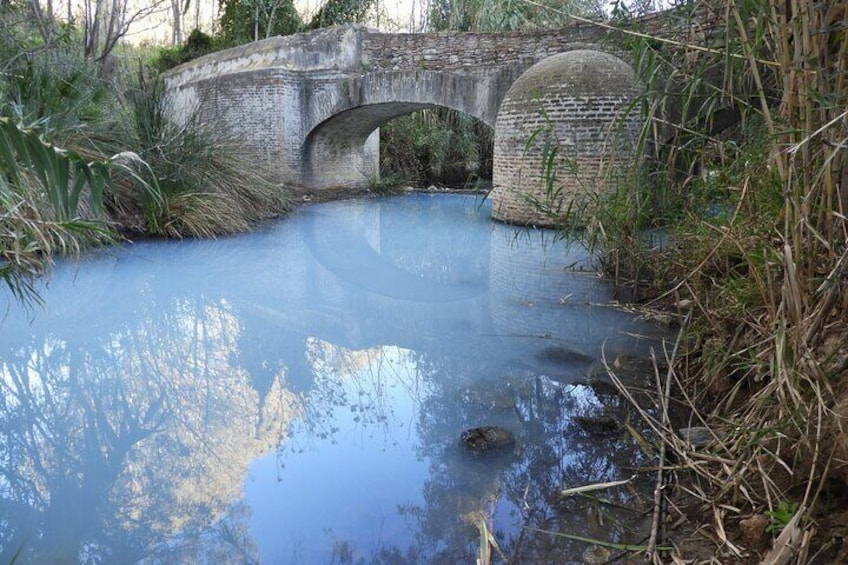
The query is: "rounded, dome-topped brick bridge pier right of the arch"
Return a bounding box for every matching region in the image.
[491,50,638,226]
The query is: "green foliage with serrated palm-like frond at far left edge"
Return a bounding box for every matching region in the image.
[0,15,121,304]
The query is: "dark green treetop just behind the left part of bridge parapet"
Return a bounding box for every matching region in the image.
[218,0,304,48]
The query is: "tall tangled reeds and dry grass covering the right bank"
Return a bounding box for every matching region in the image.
[590,0,848,563]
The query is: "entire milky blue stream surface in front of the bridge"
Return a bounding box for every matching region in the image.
[0,195,659,563]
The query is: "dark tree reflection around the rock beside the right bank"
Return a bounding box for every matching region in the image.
[318,346,650,563]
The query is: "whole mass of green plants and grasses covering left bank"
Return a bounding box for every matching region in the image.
[0,11,294,302]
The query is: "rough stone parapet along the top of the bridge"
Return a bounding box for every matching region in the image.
[165,25,616,89]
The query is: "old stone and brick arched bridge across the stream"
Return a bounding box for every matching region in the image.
[165,25,632,223]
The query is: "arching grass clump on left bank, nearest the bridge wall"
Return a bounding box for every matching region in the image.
[83,76,289,237]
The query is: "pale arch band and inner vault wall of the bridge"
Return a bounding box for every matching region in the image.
[303,71,512,187]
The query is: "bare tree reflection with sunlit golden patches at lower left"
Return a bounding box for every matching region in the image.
[0,299,291,562]
